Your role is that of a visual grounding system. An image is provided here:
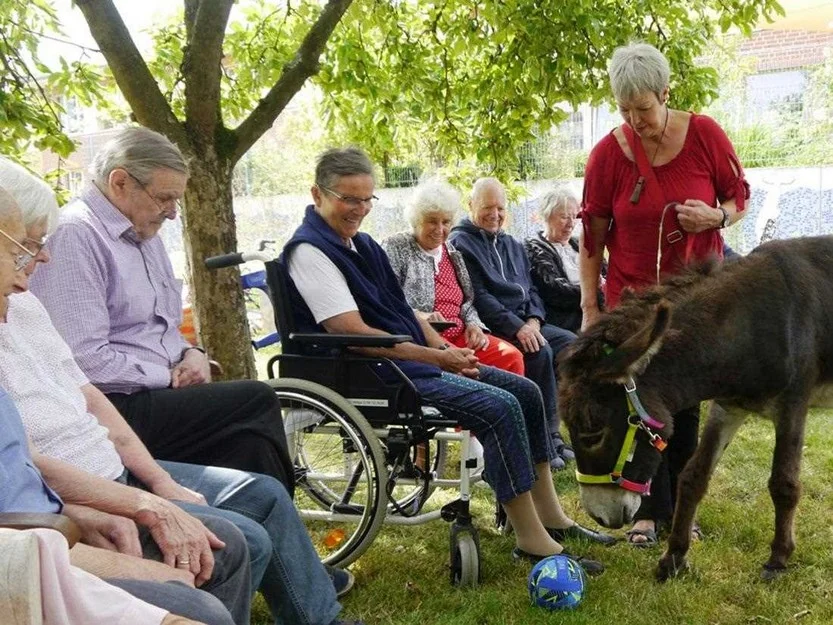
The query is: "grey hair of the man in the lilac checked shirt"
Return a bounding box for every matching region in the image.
[90,126,190,185]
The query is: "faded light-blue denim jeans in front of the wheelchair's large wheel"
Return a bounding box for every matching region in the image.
[159,461,341,625]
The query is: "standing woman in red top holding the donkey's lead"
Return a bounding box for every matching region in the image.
[579,43,749,546]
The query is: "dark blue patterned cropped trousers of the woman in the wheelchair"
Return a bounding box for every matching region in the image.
[413,366,555,503]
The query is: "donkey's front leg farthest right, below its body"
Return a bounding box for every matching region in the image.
[761,396,808,580]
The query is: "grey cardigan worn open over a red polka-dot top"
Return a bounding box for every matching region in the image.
[382,232,488,330]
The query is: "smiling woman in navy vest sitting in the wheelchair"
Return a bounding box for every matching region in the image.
[283,148,616,573]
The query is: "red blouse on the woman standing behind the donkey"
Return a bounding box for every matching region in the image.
[581,114,749,308]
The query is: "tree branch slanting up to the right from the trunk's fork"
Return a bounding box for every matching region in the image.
[231,0,353,163]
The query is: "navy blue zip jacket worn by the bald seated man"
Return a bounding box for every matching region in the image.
[449,217,546,339]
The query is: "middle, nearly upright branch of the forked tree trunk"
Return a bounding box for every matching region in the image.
[182,0,234,142]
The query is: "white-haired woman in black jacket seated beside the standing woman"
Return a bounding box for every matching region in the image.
[524,186,604,332]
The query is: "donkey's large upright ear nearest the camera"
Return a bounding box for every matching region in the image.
[593,301,671,384]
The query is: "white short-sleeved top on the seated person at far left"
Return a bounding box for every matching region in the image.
[0,293,124,480]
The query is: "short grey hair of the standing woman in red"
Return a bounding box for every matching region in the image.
[607,43,671,100]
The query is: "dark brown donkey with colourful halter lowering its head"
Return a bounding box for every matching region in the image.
[558,237,833,581]
